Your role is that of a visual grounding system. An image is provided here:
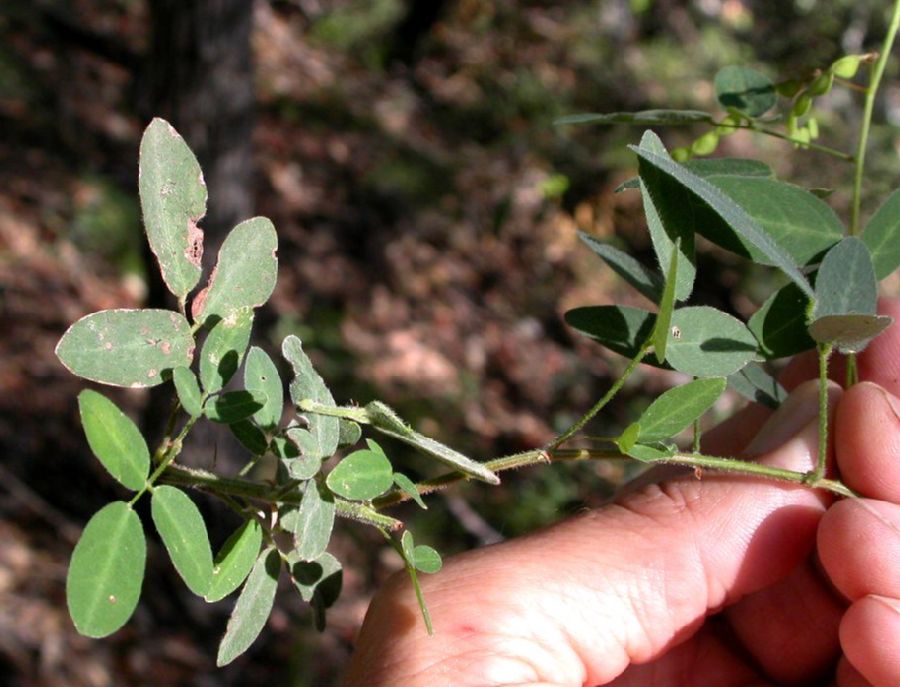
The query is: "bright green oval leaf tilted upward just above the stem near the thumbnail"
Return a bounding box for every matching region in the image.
[637,377,726,443]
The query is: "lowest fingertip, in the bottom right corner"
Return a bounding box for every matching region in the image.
[841,596,900,687]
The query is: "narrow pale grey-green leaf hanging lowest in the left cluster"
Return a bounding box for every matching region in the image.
[216,547,281,668]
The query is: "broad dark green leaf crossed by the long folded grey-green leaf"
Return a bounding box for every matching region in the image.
[697,176,844,266]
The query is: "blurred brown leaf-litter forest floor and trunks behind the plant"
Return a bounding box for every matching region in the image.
[0,0,900,687]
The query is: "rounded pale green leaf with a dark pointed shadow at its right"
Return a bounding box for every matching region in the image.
[666,306,756,377]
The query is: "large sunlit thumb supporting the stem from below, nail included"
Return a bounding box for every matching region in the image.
[349,385,840,687]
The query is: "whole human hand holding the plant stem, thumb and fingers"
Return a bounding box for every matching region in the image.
[345,301,900,687]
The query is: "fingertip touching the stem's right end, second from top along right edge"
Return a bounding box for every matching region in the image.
[834,384,900,503]
